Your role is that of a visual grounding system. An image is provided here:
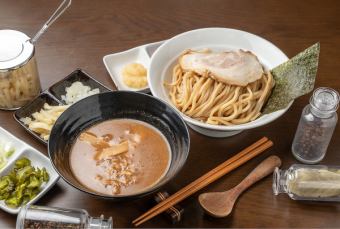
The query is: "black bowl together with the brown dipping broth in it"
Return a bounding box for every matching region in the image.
[48,91,190,199]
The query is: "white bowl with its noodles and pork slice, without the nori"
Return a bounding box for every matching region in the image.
[148,28,291,137]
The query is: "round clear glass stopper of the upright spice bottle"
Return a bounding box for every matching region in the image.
[311,87,339,112]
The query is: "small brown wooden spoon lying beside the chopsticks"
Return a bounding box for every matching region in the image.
[198,156,281,217]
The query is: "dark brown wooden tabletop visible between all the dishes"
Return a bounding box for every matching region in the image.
[0,0,340,228]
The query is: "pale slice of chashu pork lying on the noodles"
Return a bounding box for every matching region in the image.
[179,50,264,86]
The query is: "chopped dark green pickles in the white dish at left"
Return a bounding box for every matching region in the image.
[0,157,49,208]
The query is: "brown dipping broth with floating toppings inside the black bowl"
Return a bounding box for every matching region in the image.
[70,119,171,195]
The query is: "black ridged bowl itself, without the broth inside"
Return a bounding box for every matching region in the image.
[48,91,190,200]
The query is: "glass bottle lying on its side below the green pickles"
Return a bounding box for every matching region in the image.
[16,205,112,229]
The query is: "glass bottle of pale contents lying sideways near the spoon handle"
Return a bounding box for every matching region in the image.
[273,164,340,202]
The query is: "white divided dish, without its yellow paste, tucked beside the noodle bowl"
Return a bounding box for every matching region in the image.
[103,41,164,93]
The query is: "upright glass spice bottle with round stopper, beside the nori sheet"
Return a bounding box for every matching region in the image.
[292,87,339,164]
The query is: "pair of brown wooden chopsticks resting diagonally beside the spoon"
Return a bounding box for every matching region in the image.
[132,137,273,226]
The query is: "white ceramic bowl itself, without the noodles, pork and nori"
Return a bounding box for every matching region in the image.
[148,28,293,137]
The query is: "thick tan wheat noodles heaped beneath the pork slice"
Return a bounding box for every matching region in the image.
[166,64,274,125]
